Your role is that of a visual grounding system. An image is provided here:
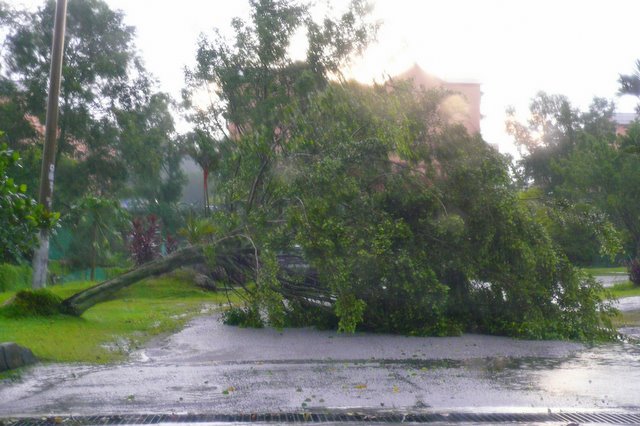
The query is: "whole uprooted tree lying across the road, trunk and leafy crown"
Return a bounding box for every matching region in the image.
[53,0,615,340]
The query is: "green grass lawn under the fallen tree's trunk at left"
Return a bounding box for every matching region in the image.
[0,277,238,363]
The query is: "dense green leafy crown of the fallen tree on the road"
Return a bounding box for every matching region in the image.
[219,79,613,340]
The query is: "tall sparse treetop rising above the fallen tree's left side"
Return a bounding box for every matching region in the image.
[184,0,377,214]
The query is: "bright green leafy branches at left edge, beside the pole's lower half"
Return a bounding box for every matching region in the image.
[0,141,59,262]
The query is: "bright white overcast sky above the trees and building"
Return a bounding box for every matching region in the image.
[15,0,640,156]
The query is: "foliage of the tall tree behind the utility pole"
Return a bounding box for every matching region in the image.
[0,0,185,207]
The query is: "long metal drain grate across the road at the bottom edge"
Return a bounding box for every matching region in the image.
[0,412,640,426]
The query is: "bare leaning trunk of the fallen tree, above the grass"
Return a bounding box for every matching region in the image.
[62,246,205,316]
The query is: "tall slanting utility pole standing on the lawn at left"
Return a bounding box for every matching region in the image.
[32,0,67,289]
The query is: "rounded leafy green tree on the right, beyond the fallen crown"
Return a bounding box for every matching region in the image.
[507,93,637,265]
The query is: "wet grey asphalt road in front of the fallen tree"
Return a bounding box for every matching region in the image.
[0,316,640,417]
